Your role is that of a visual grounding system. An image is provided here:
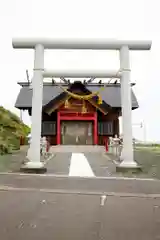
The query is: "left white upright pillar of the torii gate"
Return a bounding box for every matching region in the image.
[26,44,44,169]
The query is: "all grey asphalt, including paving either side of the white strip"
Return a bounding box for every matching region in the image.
[0,148,160,240]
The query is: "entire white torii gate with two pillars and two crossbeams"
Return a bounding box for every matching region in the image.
[12,38,152,169]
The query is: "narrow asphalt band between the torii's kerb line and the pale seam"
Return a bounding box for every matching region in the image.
[0,174,160,194]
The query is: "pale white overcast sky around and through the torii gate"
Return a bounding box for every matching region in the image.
[0,0,160,141]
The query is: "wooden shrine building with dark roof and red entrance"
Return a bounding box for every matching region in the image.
[15,80,138,145]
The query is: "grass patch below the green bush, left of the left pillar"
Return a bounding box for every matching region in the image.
[0,146,27,172]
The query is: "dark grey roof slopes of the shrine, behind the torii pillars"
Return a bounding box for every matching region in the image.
[15,84,138,109]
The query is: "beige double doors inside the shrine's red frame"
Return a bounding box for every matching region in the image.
[61,121,93,145]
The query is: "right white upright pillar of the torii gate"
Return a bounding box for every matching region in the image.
[119,45,137,168]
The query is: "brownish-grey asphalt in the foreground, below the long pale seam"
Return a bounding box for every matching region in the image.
[0,190,160,240]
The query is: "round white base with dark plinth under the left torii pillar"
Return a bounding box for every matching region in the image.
[20,162,47,174]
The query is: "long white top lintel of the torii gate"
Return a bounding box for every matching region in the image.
[12,38,152,50]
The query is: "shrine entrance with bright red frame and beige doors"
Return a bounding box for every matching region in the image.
[57,112,98,145]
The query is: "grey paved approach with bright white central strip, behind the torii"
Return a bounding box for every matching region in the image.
[46,152,116,177]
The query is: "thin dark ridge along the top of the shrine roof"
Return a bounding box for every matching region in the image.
[17,82,136,87]
